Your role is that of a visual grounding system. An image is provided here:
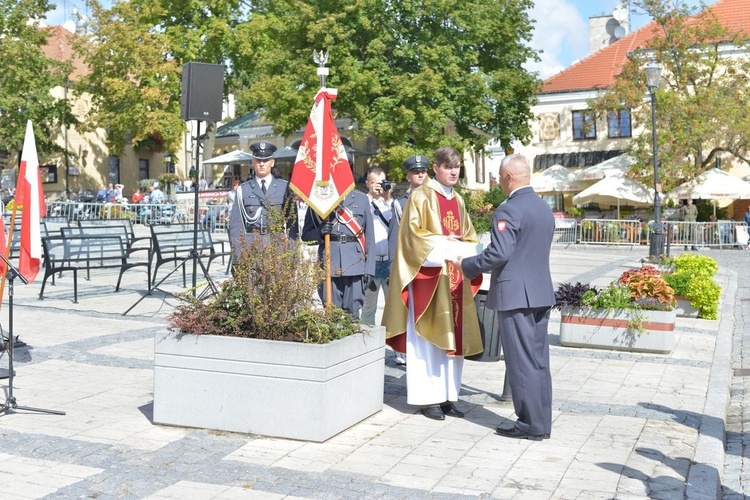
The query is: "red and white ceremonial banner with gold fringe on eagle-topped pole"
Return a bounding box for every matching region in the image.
[291,88,354,219]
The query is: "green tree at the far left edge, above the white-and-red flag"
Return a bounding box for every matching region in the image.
[0,0,74,155]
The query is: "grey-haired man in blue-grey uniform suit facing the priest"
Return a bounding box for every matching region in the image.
[457,155,555,441]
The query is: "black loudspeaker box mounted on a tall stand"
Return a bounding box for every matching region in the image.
[180,62,224,122]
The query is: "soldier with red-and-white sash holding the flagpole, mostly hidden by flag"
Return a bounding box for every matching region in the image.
[302,154,375,319]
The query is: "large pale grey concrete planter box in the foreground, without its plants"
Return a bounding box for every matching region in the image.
[154,327,385,442]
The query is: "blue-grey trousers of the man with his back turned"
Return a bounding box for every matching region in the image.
[497,307,552,435]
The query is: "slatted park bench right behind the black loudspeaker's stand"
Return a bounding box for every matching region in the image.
[151,224,231,286]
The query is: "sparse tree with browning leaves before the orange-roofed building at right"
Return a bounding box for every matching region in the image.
[592,0,750,191]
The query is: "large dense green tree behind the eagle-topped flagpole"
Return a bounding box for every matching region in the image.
[233,0,538,172]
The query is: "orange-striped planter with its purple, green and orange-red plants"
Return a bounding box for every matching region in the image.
[554,266,676,353]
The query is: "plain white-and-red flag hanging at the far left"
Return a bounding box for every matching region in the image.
[15,120,47,283]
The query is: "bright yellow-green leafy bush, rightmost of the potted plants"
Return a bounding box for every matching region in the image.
[664,253,721,319]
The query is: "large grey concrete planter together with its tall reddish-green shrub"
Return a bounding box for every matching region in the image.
[153,208,385,442]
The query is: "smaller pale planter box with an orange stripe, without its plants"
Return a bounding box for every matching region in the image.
[560,308,676,354]
